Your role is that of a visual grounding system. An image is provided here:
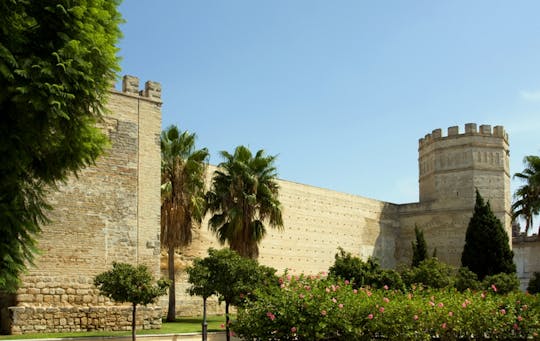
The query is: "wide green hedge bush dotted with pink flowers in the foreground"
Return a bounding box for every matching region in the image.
[231,275,540,340]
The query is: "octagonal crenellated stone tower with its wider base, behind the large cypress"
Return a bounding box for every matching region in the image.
[396,123,511,266]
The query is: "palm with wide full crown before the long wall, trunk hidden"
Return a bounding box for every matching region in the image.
[207,146,283,259]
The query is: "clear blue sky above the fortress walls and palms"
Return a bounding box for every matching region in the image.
[119,0,540,203]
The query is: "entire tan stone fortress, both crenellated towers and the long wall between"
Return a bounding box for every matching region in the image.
[0,76,540,333]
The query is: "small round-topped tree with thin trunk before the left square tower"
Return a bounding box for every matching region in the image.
[94,263,169,341]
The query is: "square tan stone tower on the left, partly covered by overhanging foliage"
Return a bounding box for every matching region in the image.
[0,76,161,334]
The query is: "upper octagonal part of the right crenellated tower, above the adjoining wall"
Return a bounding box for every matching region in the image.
[418,123,511,236]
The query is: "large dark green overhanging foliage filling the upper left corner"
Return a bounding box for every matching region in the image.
[0,0,122,291]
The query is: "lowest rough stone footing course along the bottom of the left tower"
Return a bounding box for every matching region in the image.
[9,306,162,334]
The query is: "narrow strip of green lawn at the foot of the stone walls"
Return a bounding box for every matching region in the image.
[0,316,225,340]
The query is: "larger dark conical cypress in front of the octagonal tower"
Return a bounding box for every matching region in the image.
[461,190,516,280]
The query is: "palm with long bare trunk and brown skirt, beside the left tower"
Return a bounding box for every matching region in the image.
[160,125,208,321]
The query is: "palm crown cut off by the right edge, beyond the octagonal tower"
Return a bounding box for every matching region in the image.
[512,155,540,232]
